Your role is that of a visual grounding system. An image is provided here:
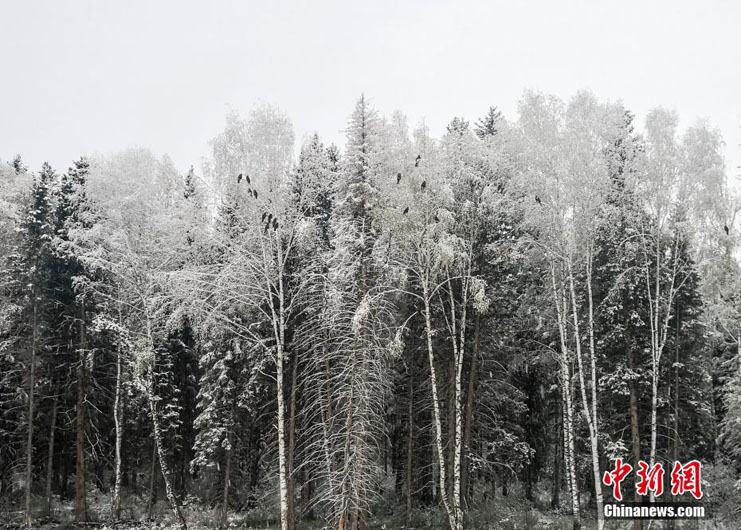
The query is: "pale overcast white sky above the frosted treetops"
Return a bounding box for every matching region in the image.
[0,0,741,176]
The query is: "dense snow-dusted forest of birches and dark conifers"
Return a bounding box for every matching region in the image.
[0,92,741,530]
